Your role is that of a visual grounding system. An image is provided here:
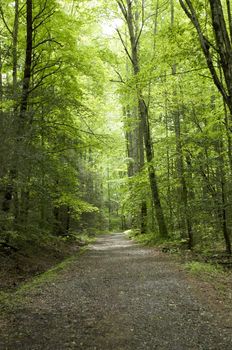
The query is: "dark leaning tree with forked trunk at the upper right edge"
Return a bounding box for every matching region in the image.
[180,0,232,254]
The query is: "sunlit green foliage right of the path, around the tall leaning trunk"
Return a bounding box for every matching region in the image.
[112,1,232,251]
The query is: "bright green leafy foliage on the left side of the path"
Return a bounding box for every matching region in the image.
[0,0,113,249]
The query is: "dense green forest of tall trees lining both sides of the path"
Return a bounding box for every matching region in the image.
[0,0,232,274]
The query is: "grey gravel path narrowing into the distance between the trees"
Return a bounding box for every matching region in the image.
[0,234,232,350]
